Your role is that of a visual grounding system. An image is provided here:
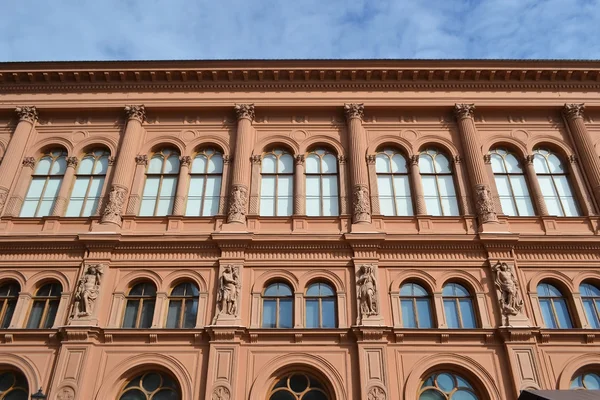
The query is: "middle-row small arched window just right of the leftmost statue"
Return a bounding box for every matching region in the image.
[123,282,156,329]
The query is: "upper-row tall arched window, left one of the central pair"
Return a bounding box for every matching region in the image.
[260,149,294,216]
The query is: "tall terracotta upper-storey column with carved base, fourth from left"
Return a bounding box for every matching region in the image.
[344,104,371,224]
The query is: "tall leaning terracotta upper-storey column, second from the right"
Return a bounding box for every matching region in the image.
[454,104,498,225]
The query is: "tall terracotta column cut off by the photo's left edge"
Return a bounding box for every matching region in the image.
[0,107,38,215]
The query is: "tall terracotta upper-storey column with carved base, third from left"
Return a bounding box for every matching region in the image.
[227,104,254,224]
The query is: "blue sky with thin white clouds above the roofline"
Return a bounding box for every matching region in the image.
[0,0,600,61]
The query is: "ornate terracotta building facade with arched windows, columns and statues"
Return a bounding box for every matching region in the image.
[0,60,600,400]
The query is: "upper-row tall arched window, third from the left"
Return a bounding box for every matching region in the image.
[140,148,179,216]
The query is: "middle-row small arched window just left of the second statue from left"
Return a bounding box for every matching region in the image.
[167,282,199,328]
